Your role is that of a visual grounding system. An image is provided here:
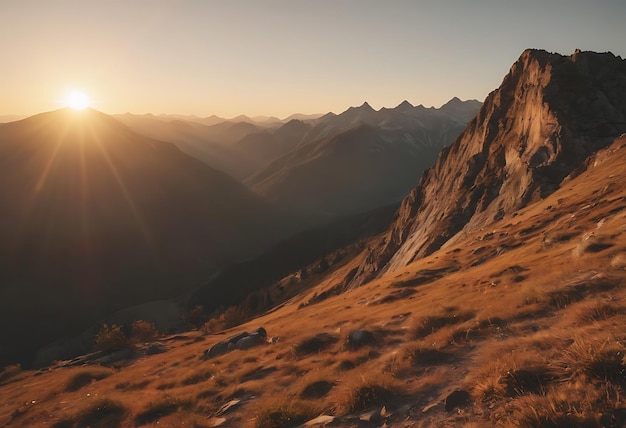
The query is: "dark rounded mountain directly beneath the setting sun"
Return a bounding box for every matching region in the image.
[0,110,287,362]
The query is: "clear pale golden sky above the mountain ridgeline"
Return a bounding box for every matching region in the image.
[0,0,626,118]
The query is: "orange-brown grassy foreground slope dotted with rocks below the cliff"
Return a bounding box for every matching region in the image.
[0,139,626,427]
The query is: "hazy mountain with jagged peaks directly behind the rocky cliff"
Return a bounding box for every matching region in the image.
[245,99,480,217]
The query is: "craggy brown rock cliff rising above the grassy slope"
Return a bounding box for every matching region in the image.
[352,50,626,285]
